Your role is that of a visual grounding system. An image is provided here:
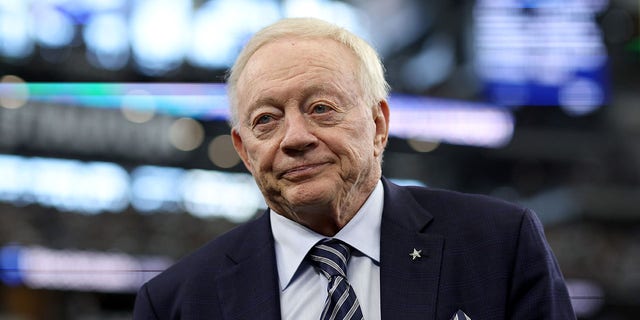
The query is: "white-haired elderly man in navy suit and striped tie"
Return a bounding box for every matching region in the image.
[134,19,575,320]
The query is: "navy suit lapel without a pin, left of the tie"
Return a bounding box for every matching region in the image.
[217,213,280,320]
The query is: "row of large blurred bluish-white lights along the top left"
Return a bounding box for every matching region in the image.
[0,0,368,76]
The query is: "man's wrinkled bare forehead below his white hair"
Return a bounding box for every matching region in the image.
[237,38,359,95]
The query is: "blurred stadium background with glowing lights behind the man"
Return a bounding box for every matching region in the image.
[0,0,640,320]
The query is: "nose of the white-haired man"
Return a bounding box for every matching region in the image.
[280,113,318,154]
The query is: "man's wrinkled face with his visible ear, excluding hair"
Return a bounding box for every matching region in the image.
[232,39,388,222]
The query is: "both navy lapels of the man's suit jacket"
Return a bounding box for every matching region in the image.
[217,178,444,320]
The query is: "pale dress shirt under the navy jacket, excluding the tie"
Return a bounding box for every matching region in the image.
[269,181,384,320]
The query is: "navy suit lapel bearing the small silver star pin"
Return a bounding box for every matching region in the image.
[380,179,444,320]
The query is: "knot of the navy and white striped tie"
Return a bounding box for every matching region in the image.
[309,239,351,278]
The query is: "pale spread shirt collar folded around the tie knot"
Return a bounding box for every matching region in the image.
[269,181,384,290]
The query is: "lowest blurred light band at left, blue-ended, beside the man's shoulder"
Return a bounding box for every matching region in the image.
[0,245,173,293]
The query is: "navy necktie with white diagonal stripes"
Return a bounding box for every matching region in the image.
[309,239,364,320]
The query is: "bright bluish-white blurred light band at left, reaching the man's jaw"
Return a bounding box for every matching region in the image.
[0,154,266,222]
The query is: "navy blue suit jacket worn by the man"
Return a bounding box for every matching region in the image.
[134,178,575,320]
